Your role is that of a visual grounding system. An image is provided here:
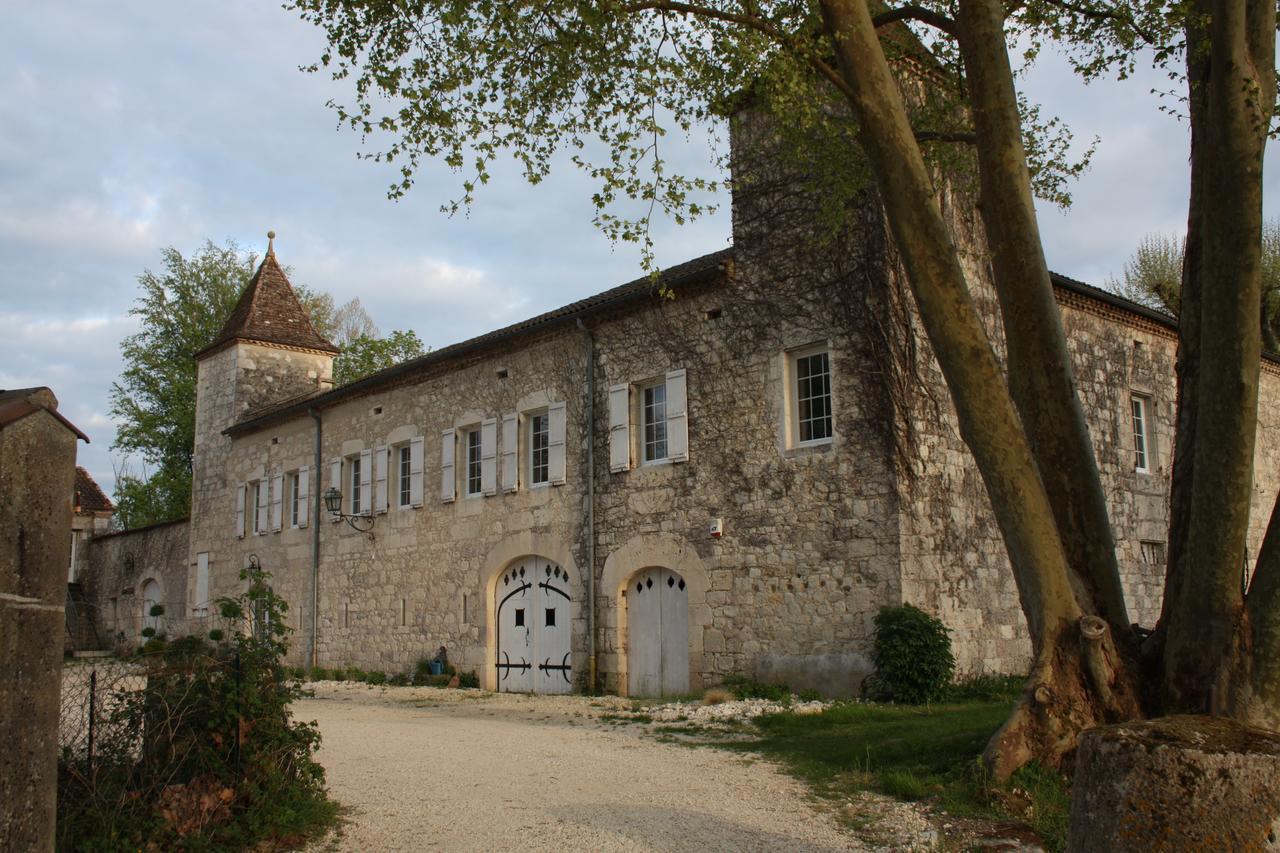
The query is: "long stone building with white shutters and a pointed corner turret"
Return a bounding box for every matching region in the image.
[85,146,1280,694]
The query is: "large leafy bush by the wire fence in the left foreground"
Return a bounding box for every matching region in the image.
[56,558,337,852]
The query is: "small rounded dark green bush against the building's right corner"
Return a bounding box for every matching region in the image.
[863,605,956,704]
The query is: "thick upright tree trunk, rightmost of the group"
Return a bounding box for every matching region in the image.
[1162,0,1275,713]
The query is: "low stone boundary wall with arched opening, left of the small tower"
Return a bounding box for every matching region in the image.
[79,520,190,652]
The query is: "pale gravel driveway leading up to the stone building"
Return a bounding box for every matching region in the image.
[303,683,932,852]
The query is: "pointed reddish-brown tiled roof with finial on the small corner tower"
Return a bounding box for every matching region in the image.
[196,247,338,359]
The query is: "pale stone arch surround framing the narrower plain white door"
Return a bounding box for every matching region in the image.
[599,533,712,693]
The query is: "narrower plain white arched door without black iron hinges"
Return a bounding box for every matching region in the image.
[626,567,689,697]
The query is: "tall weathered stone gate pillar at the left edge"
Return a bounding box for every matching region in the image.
[0,399,76,850]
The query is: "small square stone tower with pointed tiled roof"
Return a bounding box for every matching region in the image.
[191,232,338,563]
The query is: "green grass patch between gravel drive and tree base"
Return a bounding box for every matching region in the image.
[723,695,1070,849]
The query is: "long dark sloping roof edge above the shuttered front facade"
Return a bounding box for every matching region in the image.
[224,248,733,434]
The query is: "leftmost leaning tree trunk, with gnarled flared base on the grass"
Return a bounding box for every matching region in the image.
[822,0,1119,776]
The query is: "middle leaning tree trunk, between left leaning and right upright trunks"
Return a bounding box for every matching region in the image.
[957,0,1130,638]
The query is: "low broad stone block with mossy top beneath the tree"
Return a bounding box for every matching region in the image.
[1068,716,1280,853]
